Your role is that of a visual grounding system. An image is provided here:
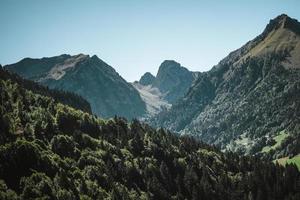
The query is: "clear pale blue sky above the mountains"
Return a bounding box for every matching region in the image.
[0,0,300,81]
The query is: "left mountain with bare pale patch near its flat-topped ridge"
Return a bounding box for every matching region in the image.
[4,54,146,119]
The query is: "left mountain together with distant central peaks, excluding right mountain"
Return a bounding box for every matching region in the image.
[4,54,198,119]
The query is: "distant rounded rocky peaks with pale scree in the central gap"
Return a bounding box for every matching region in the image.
[132,60,199,116]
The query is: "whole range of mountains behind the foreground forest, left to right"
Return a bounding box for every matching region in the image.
[4,14,300,162]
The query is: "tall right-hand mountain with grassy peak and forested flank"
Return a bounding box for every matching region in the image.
[152,15,300,159]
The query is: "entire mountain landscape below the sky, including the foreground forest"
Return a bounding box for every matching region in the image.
[0,15,300,200]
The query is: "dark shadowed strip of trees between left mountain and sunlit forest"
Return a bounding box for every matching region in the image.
[0,65,92,113]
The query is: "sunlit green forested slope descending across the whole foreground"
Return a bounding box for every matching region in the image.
[0,68,300,200]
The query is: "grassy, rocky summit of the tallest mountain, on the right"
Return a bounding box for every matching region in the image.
[216,14,300,68]
